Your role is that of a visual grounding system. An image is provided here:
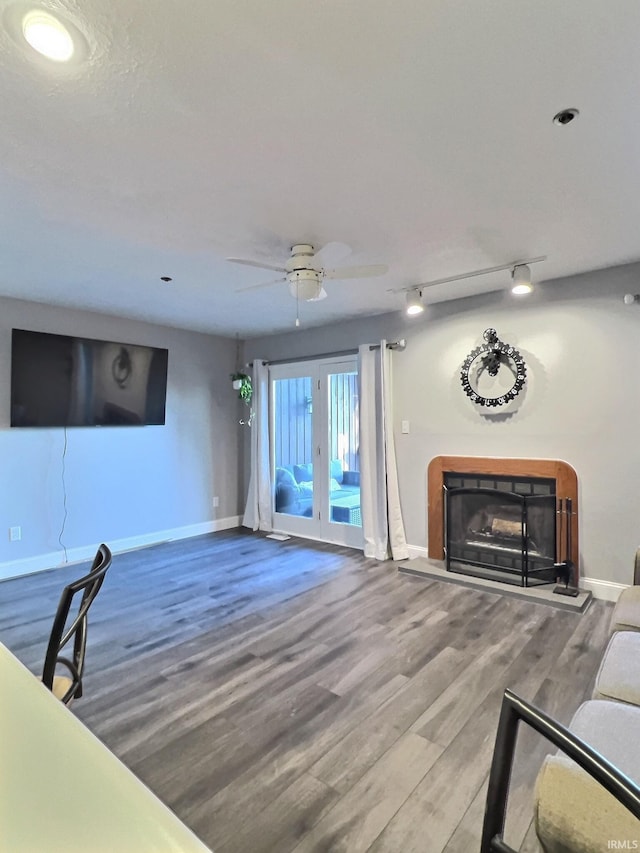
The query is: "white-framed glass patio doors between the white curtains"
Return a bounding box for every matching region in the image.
[270,357,363,548]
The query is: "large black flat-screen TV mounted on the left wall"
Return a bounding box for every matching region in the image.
[11,329,169,427]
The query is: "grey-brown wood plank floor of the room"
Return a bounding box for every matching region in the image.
[0,530,611,853]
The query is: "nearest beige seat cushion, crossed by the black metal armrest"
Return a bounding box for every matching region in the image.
[535,701,640,853]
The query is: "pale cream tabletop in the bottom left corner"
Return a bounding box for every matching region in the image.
[0,644,215,853]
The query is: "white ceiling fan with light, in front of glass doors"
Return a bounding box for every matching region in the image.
[227,243,389,302]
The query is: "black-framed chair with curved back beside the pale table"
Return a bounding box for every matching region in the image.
[42,545,111,705]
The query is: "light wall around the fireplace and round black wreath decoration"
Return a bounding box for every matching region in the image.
[245,265,640,584]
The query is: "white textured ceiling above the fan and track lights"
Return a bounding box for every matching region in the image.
[0,0,640,337]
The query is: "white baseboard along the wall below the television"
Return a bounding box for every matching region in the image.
[0,515,241,580]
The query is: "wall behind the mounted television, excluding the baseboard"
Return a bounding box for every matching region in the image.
[0,298,241,577]
